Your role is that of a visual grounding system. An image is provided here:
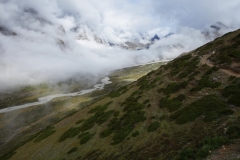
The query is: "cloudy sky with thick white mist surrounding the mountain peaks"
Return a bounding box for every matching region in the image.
[0,0,240,91]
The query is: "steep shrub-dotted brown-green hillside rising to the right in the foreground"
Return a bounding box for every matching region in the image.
[2,30,240,160]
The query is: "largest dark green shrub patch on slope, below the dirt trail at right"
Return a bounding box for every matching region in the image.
[170,95,233,124]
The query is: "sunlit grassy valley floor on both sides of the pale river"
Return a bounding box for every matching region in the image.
[0,62,165,157]
